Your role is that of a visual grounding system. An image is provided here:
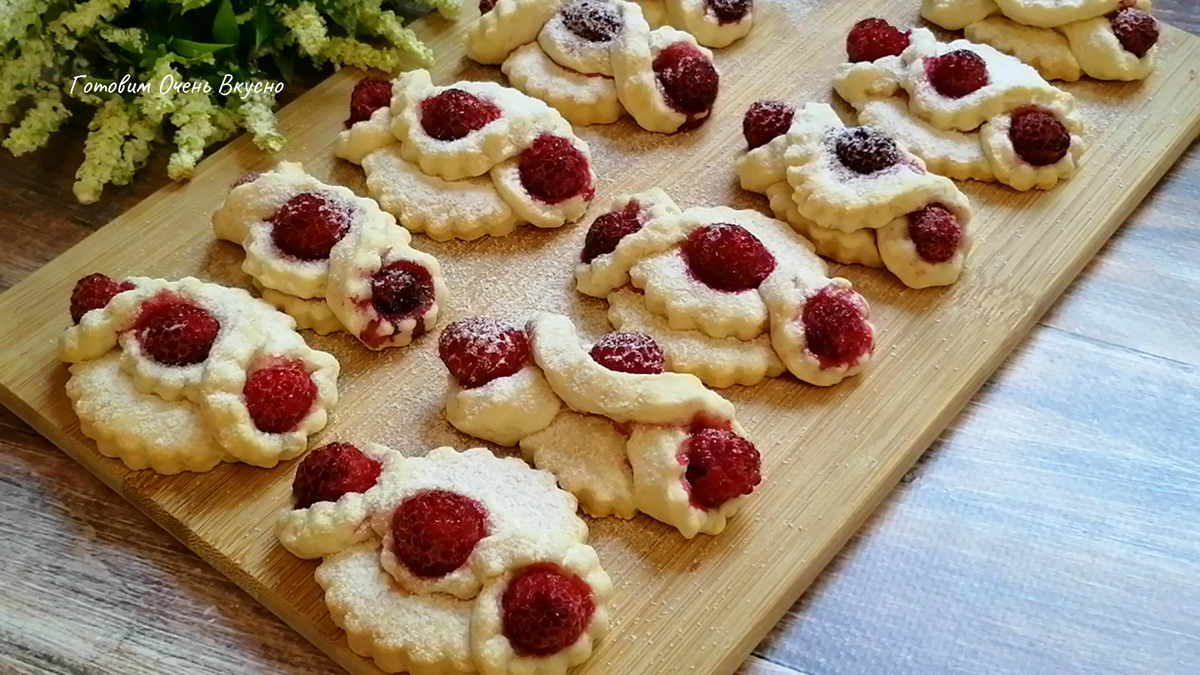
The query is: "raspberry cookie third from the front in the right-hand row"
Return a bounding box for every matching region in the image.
[575,189,874,387]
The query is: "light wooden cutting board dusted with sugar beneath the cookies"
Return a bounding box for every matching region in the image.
[0,0,1200,675]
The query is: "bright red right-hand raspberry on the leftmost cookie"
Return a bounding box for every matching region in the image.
[241,360,317,434]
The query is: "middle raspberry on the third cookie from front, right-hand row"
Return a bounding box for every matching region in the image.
[683,222,775,292]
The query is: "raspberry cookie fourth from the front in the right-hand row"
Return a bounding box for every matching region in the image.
[737,102,971,288]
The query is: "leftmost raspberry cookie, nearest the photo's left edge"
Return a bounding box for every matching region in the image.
[61,274,338,473]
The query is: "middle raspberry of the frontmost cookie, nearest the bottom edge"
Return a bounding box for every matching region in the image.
[391,490,487,579]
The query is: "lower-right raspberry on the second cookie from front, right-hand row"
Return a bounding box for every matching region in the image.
[680,429,762,509]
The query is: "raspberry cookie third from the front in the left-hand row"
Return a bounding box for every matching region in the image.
[336,71,595,241]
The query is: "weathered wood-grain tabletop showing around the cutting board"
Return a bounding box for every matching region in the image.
[0,1,1200,673]
